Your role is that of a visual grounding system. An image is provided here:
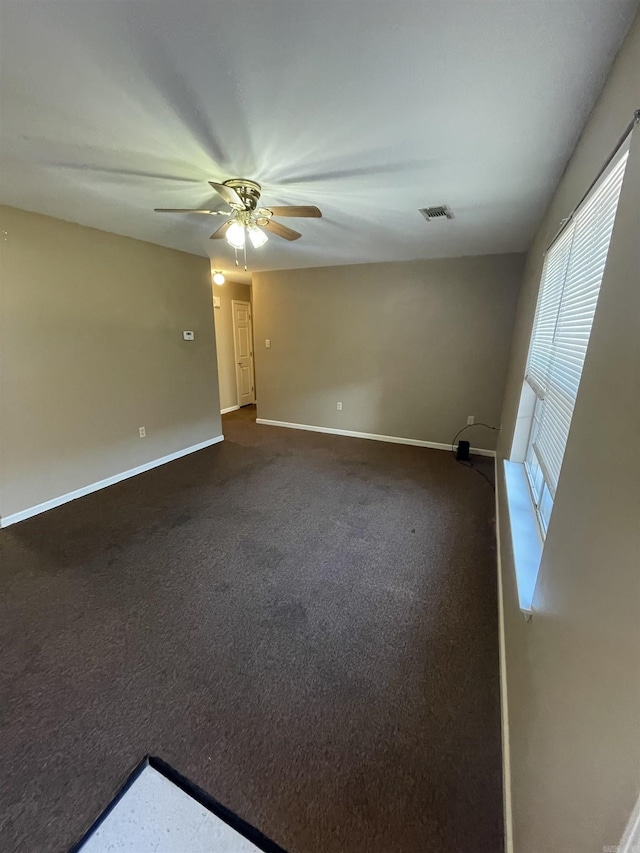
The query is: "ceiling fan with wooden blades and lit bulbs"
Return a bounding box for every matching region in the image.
[155,178,322,258]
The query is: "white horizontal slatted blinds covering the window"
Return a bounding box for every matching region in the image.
[525,148,628,496]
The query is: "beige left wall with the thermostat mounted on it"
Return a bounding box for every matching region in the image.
[0,207,221,517]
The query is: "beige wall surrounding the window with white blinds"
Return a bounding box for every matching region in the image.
[499,13,640,853]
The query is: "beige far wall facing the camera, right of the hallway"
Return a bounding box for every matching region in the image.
[253,255,524,448]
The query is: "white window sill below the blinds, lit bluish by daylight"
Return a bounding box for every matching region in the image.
[504,460,544,616]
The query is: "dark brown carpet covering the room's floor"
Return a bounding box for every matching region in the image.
[0,408,502,853]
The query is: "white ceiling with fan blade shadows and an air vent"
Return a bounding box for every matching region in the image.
[0,0,638,282]
